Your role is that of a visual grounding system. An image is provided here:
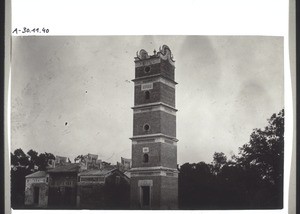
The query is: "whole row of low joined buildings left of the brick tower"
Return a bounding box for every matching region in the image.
[25,154,130,209]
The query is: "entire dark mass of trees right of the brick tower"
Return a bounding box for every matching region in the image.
[179,110,284,209]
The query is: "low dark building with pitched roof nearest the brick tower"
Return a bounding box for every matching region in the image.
[77,167,130,209]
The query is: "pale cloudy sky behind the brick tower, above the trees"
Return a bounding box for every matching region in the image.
[11,36,284,164]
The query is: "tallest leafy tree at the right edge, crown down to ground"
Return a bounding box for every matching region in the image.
[236,109,284,208]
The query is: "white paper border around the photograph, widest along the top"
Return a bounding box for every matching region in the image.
[6,0,293,214]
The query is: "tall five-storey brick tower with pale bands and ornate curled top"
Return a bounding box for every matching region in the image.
[130,45,178,209]
